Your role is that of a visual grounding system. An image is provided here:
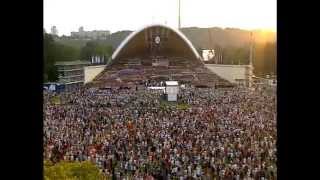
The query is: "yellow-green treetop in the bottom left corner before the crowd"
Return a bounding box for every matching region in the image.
[44,161,107,180]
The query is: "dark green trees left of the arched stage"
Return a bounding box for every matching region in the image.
[43,33,113,82]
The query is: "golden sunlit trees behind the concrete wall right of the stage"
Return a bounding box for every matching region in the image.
[206,42,277,75]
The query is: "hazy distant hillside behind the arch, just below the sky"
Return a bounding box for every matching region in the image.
[58,27,276,49]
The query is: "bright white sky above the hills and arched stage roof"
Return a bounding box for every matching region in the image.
[43,0,277,35]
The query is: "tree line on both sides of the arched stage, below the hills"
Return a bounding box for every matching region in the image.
[44,33,277,82]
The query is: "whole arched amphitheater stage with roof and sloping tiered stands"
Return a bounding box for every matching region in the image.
[88,24,231,87]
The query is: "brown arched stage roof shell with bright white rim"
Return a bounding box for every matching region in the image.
[109,24,201,63]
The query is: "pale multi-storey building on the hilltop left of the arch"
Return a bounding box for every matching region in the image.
[71,26,110,40]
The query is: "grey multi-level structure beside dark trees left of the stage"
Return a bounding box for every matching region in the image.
[55,60,90,90]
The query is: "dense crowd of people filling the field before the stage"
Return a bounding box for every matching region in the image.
[44,87,277,180]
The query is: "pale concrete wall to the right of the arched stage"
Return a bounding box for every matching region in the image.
[206,64,250,83]
